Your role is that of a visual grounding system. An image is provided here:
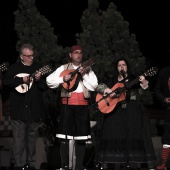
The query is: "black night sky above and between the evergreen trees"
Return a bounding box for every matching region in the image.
[0,0,170,68]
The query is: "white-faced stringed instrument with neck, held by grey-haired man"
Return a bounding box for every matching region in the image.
[15,65,52,93]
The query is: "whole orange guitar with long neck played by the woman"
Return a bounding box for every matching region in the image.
[96,67,158,114]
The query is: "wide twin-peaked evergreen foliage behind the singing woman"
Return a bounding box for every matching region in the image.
[76,0,145,82]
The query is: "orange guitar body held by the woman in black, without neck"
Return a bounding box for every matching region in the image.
[96,83,126,114]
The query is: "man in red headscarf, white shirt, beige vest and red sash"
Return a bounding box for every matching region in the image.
[46,45,98,170]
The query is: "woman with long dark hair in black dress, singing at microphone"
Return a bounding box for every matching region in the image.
[95,58,155,170]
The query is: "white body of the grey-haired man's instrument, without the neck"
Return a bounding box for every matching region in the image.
[15,73,33,93]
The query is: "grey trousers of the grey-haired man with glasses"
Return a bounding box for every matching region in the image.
[11,120,39,167]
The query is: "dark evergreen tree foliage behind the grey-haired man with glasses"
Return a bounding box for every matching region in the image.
[14,0,63,68]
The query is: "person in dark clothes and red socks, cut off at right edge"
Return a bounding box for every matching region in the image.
[154,66,170,170]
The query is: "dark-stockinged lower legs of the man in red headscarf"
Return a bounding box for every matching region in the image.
[60,139,86,170]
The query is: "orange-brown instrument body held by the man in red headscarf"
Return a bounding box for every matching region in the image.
[60,69,78,91]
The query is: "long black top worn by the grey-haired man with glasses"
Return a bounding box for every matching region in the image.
[4,62,48,121]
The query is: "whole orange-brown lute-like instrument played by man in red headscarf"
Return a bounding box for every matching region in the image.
[60,58,96,92]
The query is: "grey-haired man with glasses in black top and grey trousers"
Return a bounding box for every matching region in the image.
[4,44,48,170]
